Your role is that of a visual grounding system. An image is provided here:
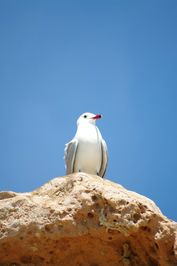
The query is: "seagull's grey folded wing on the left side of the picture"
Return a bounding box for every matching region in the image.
[64,139,78,175]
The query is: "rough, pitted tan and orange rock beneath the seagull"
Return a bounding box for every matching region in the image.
[0,173,177,266]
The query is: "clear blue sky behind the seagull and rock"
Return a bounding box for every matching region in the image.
[0,0,177,220]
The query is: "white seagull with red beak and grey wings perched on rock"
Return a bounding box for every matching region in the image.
[64,113,108,177]
